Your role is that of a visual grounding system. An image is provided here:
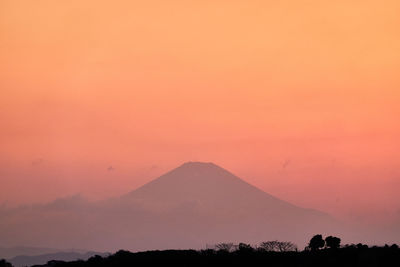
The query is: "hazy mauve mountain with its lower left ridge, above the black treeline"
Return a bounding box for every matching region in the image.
[0,162,338,251]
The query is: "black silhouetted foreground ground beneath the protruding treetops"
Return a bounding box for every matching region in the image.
[0,246,400,267]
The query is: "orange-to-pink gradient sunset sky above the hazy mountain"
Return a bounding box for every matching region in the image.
[0,0,400,226]
